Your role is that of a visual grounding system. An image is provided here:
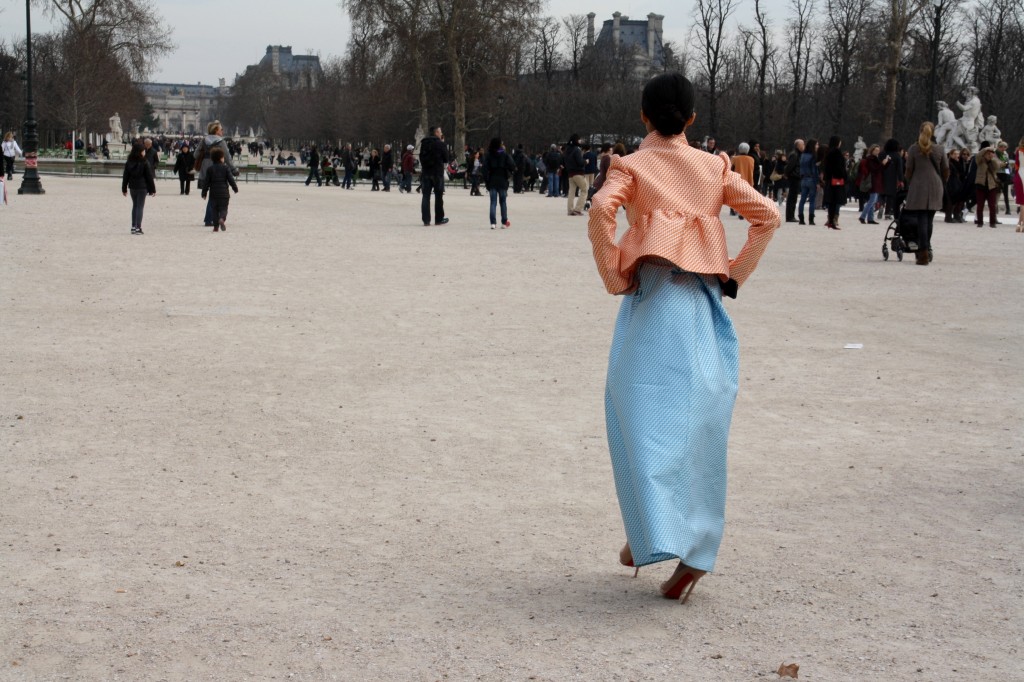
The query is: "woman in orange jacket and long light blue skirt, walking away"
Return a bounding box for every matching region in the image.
[589,74,779,602]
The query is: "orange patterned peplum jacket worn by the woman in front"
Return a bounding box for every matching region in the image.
[589,132,779,294]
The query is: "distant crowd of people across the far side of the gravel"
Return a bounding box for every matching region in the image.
[3,107,1024,242]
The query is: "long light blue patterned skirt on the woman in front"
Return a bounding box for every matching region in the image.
[605,263,739,571]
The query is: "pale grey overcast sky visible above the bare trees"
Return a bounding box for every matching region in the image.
[8,0,787,85]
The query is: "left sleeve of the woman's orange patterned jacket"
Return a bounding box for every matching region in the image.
[588,159,634,295]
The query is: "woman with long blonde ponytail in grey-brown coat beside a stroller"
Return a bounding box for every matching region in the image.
[903,121,949,265]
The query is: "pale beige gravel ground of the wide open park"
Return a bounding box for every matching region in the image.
[0,177,1024,682]
